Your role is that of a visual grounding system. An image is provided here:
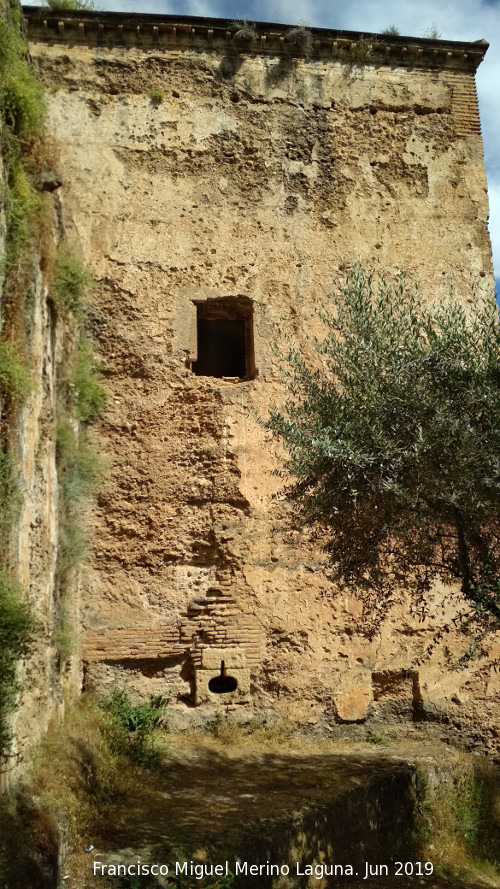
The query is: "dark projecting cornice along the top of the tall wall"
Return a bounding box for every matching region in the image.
[23,7,488,72]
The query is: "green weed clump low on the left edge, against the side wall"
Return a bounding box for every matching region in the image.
[0,566,34,756]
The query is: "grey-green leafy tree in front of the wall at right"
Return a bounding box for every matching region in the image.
[266,265,500,620]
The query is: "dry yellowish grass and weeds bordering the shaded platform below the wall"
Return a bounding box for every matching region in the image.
[0,697,500,887]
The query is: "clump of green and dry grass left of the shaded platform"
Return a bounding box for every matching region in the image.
[0,692,168,886]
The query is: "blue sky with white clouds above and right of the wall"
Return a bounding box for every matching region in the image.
[24,0,500,293]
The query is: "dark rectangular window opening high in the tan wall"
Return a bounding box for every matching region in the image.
[192,298,255,380]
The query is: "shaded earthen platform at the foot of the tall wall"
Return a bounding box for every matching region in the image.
[84,739,500,889]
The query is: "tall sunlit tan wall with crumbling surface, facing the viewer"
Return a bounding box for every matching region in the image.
[25,10,498,744]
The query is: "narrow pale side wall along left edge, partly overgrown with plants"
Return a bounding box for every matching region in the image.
[0,0,65,790]
